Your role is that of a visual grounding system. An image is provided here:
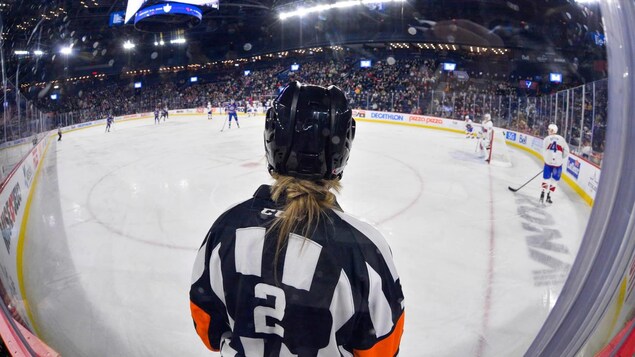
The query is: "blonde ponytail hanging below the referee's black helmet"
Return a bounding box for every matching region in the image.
[269,174,342,274]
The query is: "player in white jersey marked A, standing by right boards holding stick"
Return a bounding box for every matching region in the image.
[540,124,569,203]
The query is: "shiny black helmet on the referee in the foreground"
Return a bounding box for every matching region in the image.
[264,81,355,181]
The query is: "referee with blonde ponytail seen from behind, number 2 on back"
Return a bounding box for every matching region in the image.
[190,82,404,357]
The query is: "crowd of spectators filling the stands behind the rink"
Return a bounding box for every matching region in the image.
[2,57,608,164]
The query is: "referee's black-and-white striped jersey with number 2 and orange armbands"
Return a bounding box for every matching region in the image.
[190,185,404,357]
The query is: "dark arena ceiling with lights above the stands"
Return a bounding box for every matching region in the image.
[0,0,604,81]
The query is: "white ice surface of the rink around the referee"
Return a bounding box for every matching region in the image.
[24,115,590,357]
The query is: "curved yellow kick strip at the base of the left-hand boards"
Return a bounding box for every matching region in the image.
[15,137,53,336]
